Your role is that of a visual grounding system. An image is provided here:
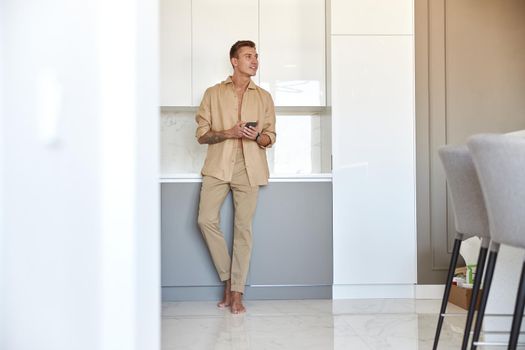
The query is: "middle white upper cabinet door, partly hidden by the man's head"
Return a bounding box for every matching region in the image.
[192,0,259,106]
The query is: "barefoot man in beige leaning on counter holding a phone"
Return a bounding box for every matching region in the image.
[195,41,276,314]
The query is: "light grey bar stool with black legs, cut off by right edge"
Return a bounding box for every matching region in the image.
[468,134,525,349]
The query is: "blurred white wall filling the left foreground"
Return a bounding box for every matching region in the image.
[0,0,160,350]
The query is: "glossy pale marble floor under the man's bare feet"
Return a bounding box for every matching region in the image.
[162,299,496,350]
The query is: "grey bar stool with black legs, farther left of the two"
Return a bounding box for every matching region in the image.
[433,145,490,350]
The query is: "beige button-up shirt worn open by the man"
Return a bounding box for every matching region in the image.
[195,77,276,186]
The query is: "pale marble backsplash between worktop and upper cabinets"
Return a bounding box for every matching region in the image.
[160,110,331,177]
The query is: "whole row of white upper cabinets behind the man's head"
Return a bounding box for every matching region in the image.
[160,0,326,106]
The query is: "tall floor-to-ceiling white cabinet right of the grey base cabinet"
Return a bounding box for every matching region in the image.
[331,0,416,299]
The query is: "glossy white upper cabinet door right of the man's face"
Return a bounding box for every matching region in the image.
[258,0,326,106]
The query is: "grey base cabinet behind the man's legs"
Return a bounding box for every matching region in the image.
[161,182,332,301]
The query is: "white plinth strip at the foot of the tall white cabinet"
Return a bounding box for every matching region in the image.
[332,284,415,299]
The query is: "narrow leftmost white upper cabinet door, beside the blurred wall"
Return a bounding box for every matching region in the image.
[159,0,192,106]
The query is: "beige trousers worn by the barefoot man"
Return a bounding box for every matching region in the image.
[198,147,259,293]
